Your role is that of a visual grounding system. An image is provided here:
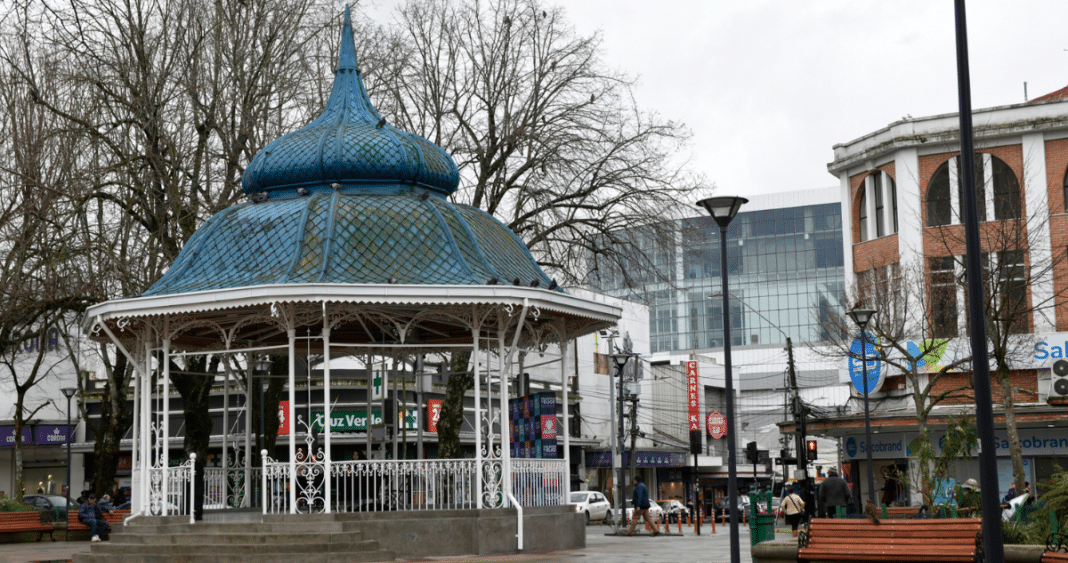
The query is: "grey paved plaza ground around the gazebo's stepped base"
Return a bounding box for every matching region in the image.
[0,526,789,563]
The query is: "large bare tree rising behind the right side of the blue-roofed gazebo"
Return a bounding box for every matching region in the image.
[367,0,703,456]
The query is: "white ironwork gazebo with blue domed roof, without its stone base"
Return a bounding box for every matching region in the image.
[87,9,621,529]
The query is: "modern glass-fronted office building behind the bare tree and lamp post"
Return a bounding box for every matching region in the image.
[593,188,845,354]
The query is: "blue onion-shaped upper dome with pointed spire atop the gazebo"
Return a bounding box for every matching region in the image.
[241,7,459,200]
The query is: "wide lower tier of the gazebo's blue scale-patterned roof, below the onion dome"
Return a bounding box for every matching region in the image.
[143,192,562,296]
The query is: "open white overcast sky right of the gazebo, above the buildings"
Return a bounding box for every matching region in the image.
[371,0,1068,196]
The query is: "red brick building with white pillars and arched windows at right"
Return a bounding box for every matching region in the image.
[808,89,1068,502]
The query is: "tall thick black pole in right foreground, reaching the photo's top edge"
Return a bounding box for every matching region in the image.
[954,0,1005,563]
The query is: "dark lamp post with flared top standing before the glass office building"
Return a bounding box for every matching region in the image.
[697,196,749,563]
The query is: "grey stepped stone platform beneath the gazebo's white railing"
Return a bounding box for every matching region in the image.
[74,505,586,563]
